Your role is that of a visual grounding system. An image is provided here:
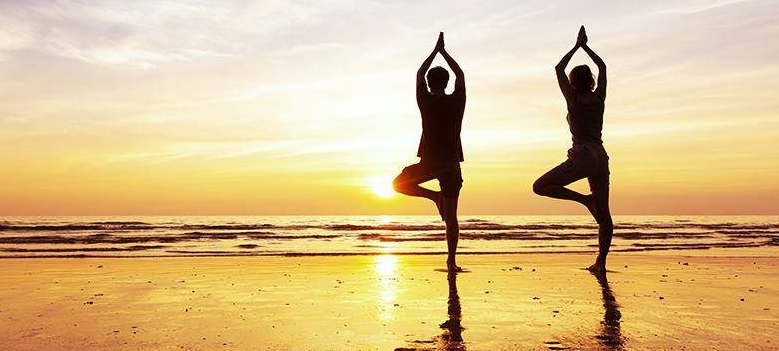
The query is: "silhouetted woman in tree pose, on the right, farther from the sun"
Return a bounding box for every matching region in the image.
[533,26,614,272]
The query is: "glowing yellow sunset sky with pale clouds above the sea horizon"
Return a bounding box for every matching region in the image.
[0,0,779,215]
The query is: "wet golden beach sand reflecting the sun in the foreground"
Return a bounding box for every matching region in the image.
[0,251,779,351]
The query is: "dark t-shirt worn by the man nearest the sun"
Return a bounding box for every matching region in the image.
[417,84,465,163]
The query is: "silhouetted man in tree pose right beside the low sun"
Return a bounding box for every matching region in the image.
[393,32,465,272]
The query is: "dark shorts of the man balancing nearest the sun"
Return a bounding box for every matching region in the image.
[395,162,463,197]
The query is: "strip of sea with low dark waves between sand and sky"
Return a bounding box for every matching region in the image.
[0,216,779,257]
